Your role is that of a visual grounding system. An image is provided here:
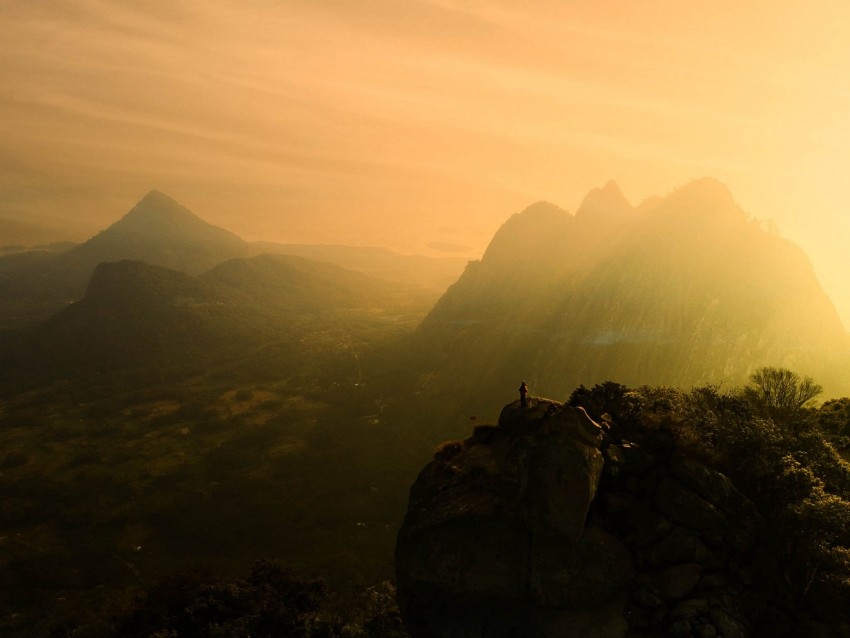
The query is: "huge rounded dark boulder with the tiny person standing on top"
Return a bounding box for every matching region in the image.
[396,400,620,638]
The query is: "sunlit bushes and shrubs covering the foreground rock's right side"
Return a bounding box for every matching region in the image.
[569,368,850,636]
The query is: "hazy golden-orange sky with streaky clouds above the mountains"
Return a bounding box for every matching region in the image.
[0,0,850,327]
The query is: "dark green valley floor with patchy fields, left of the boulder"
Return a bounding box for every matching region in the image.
[0,324,428,636]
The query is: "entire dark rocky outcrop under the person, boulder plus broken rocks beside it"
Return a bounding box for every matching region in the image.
[396,399,776,638]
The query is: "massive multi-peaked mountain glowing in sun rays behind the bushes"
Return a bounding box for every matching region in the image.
[415,179,850,428]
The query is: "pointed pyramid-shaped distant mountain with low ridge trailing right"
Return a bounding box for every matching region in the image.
[0,190,464,329]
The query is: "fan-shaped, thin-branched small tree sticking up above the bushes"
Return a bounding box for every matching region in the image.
[744,367,823,419]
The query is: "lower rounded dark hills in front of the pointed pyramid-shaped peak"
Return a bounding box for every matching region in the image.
[3,255,418,383]
